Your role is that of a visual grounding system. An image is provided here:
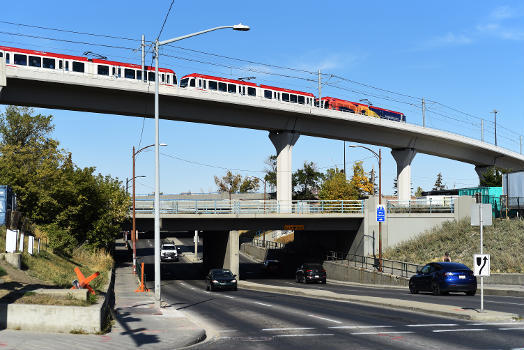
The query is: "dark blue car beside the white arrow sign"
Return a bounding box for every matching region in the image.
[409,262,477,295]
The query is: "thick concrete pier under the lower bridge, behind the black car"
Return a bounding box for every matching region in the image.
[203,231,239,276]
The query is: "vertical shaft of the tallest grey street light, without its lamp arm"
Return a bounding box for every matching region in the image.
[154,40,161,308]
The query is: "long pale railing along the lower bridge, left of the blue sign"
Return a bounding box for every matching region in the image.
[135,199,364,214]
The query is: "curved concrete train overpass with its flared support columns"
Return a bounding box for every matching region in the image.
[0,58,524,206]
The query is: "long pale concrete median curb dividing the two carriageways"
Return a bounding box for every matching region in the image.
[239,281,520,321]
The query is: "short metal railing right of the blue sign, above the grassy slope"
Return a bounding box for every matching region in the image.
[387,197,456,213]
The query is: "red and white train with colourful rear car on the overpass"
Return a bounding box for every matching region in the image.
[0,46,406,122]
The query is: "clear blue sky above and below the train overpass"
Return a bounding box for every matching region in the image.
[0,0,524,194]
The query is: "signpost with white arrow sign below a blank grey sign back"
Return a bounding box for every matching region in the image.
[471,200,492,312]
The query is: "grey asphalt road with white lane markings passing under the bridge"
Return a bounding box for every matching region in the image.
[136,240,524,349]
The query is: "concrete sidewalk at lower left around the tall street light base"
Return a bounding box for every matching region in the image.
[0,240,206,350]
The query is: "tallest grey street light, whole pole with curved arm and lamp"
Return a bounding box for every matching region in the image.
[154,23,250,308]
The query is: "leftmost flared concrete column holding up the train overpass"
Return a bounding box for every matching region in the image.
[269,131,300,213]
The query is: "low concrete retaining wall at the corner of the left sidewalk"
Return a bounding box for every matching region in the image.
[0,270,115,333]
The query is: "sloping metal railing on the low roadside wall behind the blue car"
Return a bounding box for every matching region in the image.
[326,251,423,277]
